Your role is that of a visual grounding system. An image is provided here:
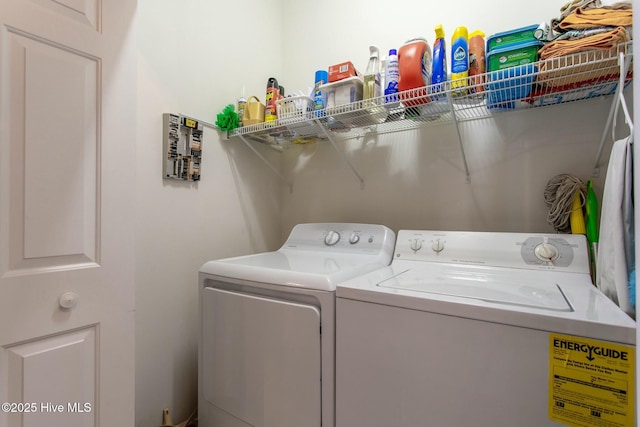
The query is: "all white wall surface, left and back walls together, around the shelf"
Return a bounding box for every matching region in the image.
[136,0,636,427]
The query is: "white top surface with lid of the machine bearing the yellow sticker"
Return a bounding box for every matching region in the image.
[336,260,635,344]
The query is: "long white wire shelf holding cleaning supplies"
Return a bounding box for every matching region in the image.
[228,42,633,149]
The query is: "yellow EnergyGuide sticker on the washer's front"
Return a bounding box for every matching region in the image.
[549,334,635,427]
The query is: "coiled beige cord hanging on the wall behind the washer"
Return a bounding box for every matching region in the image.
[544,174,587,233]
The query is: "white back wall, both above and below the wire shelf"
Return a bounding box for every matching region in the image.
[274,0,624,237]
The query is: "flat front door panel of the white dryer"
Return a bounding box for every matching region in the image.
[202,288,321,427]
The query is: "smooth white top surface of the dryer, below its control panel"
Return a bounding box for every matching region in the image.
[200,249,388,291]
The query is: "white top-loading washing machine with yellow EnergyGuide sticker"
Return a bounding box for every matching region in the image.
[336,230,636,427]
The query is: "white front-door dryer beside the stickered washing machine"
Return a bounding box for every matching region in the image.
[198,223,395,427]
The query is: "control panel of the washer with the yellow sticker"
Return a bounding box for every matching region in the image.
[394,230,589,273]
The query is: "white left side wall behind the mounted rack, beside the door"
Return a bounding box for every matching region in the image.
[132,0,282,427]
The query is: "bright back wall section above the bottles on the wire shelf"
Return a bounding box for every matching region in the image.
[282,0,564,91]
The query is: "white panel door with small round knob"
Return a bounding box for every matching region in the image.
[0,0,136,427]
